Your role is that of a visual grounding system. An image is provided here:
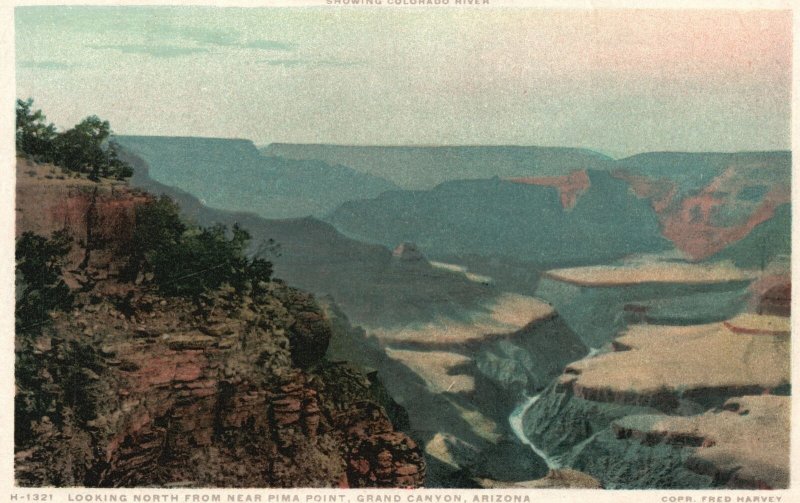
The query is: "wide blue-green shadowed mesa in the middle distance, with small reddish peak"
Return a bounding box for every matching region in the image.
[328,171,670,265]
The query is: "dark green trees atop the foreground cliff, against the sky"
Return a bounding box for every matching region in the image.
[16,99,133,180]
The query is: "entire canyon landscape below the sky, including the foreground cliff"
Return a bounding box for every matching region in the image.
[17,137,791,488]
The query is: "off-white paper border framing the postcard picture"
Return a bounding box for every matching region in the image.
[0,0,800,503]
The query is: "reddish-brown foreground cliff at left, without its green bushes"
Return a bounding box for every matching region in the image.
[15,161,426,487]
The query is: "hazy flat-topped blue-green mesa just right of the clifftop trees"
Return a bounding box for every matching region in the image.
[116,136,396,218]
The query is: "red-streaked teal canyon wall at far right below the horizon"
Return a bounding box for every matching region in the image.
[614,152,792,260]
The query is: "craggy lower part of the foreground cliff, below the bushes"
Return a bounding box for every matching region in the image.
[16,284,425,487]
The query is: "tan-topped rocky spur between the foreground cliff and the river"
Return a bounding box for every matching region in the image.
[329,296,588,487]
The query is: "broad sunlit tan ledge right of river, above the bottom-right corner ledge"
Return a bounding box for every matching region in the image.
[558,314,790,413]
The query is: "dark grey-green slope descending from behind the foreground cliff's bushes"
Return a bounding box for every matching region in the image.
[120,150,497,325]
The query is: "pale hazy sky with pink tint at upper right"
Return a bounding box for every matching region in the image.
[15,5,791,155]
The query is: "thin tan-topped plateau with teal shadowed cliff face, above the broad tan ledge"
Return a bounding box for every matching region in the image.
[536,260,755,348]
